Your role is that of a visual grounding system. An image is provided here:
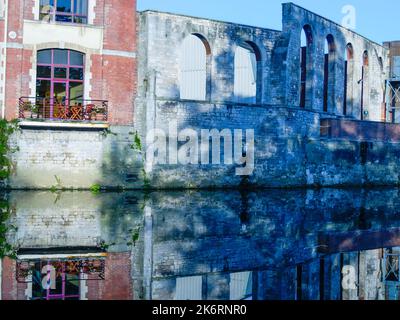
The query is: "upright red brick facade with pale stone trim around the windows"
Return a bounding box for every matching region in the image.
[0,0,137,125]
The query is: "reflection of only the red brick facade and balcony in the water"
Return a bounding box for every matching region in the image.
[2,250,132,300]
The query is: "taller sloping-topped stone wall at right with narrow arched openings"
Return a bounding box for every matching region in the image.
[280,3,390,121]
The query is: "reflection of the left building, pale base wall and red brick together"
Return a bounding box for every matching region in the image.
[0,192,139,300]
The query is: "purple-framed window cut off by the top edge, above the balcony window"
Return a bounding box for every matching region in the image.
[40,0,88,24]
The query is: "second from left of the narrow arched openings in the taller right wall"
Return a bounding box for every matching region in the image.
[323,35,336,112]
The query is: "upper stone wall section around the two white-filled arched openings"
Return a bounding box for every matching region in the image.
[138,11,280,103]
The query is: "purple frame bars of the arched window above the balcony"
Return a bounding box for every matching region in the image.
[36,48,85,118]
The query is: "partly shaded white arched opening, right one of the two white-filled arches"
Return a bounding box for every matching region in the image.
[234,42,261,103]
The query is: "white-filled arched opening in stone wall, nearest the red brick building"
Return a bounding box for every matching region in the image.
[180,34,211,101]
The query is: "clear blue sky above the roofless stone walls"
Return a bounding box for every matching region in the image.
[138,0,400,43]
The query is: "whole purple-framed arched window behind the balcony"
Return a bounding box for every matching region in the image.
[36,49,85,118]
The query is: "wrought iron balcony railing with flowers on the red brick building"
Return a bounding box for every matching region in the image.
[19,97,108,122]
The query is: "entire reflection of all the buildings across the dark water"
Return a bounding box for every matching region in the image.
[0,190,400,300]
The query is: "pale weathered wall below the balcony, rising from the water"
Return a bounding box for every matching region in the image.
[10,127,143,189]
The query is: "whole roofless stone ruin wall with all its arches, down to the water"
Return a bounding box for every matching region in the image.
[122,4,399,188]
